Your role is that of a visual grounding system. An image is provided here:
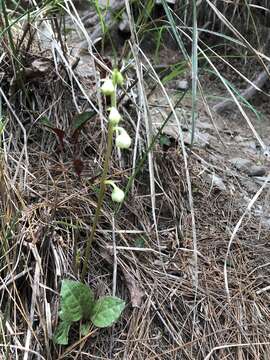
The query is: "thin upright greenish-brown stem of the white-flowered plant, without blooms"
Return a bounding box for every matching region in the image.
[81,92,116,280]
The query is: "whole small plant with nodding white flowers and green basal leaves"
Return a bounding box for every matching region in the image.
[54,69,131,345]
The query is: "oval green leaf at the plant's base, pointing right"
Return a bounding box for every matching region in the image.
[91,296,125,328]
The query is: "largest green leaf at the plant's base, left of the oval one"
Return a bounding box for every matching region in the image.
[59,280,94,322]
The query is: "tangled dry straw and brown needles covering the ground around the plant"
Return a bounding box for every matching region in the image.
[0,0,270,360]
